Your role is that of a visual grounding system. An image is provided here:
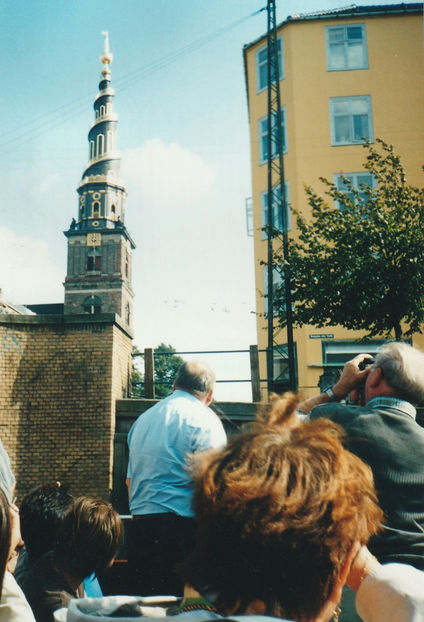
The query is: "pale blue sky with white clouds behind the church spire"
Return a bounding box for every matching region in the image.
[0,0,418,399]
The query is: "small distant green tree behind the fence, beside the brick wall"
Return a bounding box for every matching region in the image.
[131,343,183,398]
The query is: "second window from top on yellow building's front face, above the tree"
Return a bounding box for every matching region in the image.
[330,95,373,145]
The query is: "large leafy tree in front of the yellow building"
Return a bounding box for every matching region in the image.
[275,139,424,340]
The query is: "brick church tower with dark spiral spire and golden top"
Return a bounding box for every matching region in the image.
[64,32,135,327]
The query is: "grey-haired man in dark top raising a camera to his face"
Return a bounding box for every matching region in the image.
[299,342,424,570]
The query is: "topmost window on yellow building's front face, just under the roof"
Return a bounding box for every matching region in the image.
[326,24,368,71]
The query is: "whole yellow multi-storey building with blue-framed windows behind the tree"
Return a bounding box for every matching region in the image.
[244,3,424,396]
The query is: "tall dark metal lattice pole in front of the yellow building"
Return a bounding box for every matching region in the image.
[267,0,296,392]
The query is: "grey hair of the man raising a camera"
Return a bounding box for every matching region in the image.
[374,341,424,404]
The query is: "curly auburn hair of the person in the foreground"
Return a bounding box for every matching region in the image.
[182,393,382,620]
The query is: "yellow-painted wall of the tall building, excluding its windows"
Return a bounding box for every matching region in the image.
[245,15,424,394]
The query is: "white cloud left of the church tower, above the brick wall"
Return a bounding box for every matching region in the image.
[0,227,65,304]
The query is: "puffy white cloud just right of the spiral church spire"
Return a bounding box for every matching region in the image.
[122,138,215,205]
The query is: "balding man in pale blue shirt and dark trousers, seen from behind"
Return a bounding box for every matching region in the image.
[127,361,226,594]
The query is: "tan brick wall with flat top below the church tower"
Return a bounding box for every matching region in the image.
[0,314,132,499]
